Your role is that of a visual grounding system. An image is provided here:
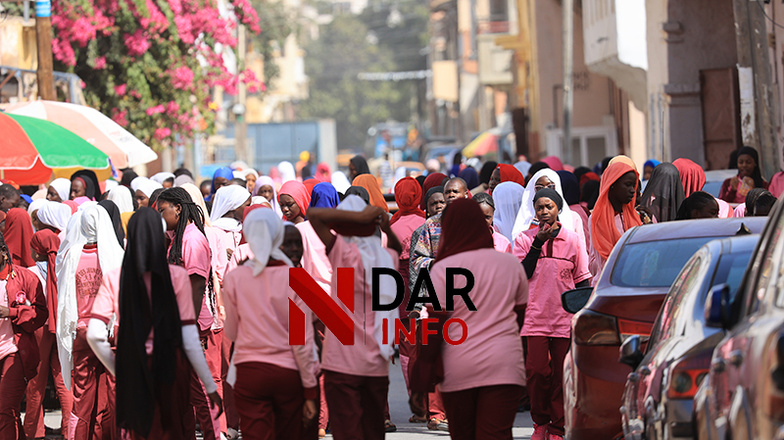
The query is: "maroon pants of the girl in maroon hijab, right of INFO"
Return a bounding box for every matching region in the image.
[441,385,523,440]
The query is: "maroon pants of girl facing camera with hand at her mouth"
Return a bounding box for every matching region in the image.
[525,336,570,435]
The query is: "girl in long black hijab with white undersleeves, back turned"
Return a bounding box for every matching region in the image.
[87,208,221,439]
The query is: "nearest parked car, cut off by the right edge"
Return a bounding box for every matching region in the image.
[694,203,784,440]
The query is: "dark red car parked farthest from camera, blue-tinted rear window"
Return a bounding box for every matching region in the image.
[562,218,765,440]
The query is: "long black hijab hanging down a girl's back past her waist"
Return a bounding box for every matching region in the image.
[116,208,182,437]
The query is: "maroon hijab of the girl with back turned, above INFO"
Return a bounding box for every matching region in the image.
[436,199,493,261]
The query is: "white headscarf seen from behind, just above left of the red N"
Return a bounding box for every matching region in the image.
[243,208,294,276]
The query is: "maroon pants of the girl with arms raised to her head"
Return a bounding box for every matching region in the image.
[324,371,389,440]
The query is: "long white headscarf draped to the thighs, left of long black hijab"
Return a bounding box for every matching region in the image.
[57,206,125,389]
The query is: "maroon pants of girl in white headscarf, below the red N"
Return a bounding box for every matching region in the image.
[234,362,318,440]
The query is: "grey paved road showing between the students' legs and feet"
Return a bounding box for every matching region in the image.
[39,362,533,440]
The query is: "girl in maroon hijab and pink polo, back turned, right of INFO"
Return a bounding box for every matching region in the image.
[428,199,528,439]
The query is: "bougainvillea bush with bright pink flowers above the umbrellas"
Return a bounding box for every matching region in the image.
[52,0,263,149]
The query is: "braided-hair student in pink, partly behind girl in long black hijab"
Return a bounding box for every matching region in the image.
[156,188,222,440]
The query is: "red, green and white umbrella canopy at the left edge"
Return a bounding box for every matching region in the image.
[0,113,111,185]
